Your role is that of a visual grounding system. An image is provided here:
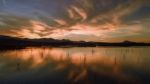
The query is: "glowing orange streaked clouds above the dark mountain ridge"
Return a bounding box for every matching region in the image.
[1,0,149,40]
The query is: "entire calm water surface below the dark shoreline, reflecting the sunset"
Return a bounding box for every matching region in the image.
[0,47,150,84]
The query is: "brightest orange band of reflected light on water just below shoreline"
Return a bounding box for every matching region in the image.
[1,48,142,70]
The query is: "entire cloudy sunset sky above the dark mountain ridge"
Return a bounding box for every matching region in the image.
[0,0,150,42]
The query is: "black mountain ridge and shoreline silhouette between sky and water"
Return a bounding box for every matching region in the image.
[0,35,150,49]
